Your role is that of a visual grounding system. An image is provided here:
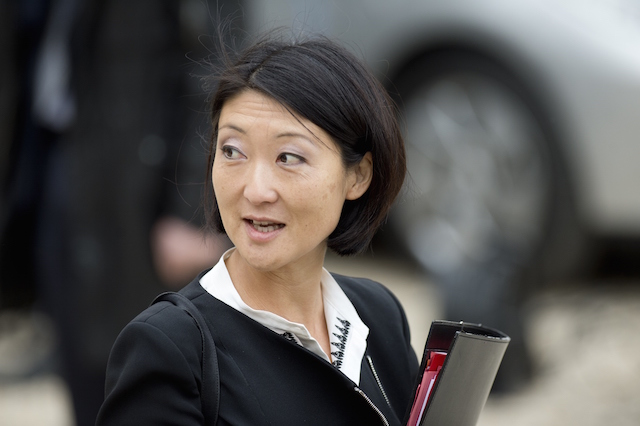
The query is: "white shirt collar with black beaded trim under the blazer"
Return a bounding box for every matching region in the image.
[200,248,369,384]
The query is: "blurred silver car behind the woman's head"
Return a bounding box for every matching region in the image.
[245,0,640,280]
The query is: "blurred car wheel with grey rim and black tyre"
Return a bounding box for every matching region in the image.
[390,51,580,292]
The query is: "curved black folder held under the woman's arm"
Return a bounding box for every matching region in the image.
[404,321,511,426]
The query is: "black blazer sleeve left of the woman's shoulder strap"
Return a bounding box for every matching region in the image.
[96,321,203,426]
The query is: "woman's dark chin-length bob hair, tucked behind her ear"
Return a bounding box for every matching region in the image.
[205,35,406,255]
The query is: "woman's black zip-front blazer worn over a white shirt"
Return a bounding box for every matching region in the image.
[97,275,418,426]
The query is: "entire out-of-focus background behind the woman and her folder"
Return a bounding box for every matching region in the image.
[0,0,640,426]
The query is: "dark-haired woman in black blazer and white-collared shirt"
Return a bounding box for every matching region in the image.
[98,34,418,425]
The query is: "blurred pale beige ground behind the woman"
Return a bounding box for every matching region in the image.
[0,251,640,426]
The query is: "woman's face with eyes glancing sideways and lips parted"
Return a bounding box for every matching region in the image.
[212,90,369,271]
